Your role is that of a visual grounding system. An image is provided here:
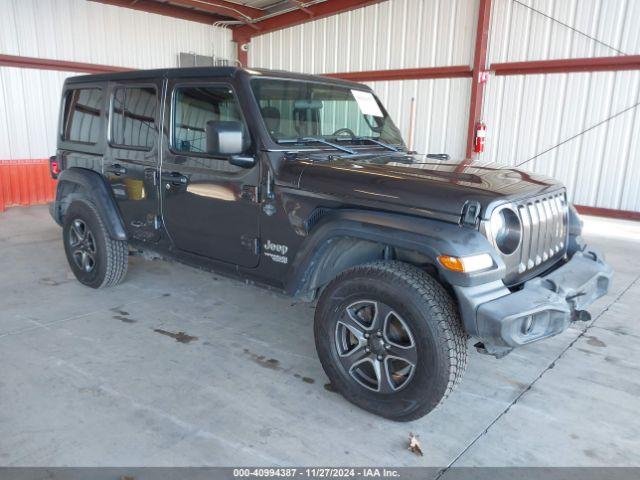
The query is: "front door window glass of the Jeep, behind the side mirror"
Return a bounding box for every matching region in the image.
[173,85,246,154]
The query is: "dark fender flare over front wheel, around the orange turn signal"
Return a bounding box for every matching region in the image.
[285,210,505,295]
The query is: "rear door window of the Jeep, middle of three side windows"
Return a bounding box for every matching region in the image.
[111,87,157,150]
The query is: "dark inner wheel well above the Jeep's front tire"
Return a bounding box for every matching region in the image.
[299,237,444,298]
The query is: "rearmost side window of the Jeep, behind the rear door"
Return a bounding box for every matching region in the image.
[62,88,102,145]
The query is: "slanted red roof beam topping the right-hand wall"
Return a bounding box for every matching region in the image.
[233,0,384,41]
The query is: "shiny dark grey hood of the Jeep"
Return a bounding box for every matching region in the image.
[298,155,562,221]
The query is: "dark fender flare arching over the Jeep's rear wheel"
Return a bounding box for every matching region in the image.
[51,167,127,240]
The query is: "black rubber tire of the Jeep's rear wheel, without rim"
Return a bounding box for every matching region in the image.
[62,200,129,288]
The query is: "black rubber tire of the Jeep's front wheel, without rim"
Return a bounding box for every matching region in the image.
[314,261,467,422]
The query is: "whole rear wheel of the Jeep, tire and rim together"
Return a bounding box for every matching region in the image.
[62,200,128,288]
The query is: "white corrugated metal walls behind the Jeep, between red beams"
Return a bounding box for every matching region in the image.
[0,0,640,214]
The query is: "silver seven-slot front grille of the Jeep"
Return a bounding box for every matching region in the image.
[516,192,567,274]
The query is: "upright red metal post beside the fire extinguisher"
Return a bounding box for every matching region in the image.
[465,0,491,160]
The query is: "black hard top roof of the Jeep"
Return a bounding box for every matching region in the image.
[66,67,367,88]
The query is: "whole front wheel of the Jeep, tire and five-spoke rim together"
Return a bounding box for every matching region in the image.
[315,261,467,421]
